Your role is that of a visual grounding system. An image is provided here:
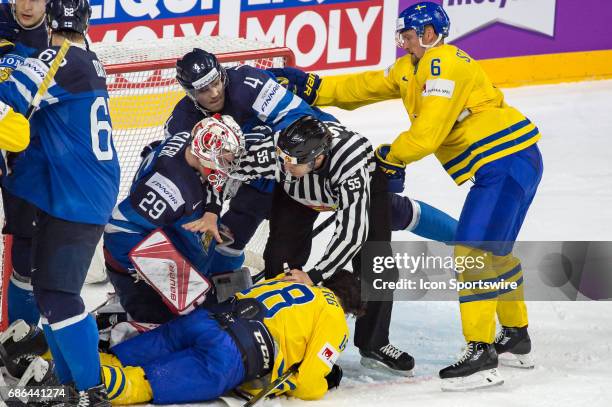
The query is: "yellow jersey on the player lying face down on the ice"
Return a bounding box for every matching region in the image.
[237,279,349,400]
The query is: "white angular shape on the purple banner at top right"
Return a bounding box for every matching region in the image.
[442,0,557,41]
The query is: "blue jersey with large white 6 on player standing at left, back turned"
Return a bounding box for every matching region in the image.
[0,45,119,225]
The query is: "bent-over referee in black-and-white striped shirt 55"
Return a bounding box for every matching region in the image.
[264,116,414,376]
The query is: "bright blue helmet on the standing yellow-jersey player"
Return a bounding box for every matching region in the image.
[396,1,450,37]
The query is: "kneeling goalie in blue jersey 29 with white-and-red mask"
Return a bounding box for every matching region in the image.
[104,116,245,323]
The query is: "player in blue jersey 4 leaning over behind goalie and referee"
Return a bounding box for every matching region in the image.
[171,49,456,280]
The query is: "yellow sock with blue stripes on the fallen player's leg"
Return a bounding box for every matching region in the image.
[102,365,153,405]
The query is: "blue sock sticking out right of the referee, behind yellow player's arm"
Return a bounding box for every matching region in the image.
[408,201,458,242]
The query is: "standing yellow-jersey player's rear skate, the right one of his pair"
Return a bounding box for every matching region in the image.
[495,326,535,369]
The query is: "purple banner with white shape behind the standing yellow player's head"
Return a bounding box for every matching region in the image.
[397,0,612,59]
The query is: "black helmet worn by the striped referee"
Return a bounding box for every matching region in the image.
[276,116,332,164]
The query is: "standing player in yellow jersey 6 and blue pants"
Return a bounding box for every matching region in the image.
[268,2,542,390]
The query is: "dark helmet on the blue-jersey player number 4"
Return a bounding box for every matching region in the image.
[176,48,227,100]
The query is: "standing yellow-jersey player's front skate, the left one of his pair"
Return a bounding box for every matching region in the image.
[440,342,504,391]
